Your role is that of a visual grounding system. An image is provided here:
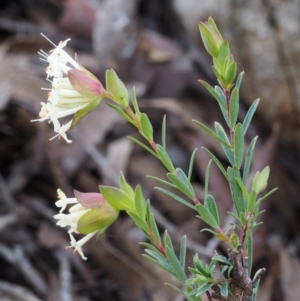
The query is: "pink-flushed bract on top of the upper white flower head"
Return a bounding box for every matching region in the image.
[68,68,105,97]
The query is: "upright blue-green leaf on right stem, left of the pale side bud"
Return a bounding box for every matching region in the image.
[227,167,245,214]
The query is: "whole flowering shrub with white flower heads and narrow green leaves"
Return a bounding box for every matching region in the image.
[34,18,275,301]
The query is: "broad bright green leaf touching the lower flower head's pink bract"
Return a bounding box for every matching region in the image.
[99,186,134,211]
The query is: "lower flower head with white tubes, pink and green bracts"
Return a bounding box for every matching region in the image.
[54,189,119,260]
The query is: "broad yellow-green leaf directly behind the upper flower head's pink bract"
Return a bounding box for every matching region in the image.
[105,69,128,107]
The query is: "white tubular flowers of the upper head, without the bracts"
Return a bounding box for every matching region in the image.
[32,36,91,143]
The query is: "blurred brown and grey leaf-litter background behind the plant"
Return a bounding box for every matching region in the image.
[0,0,300,301]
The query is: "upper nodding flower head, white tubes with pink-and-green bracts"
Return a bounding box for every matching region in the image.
[33,37,105,143]
